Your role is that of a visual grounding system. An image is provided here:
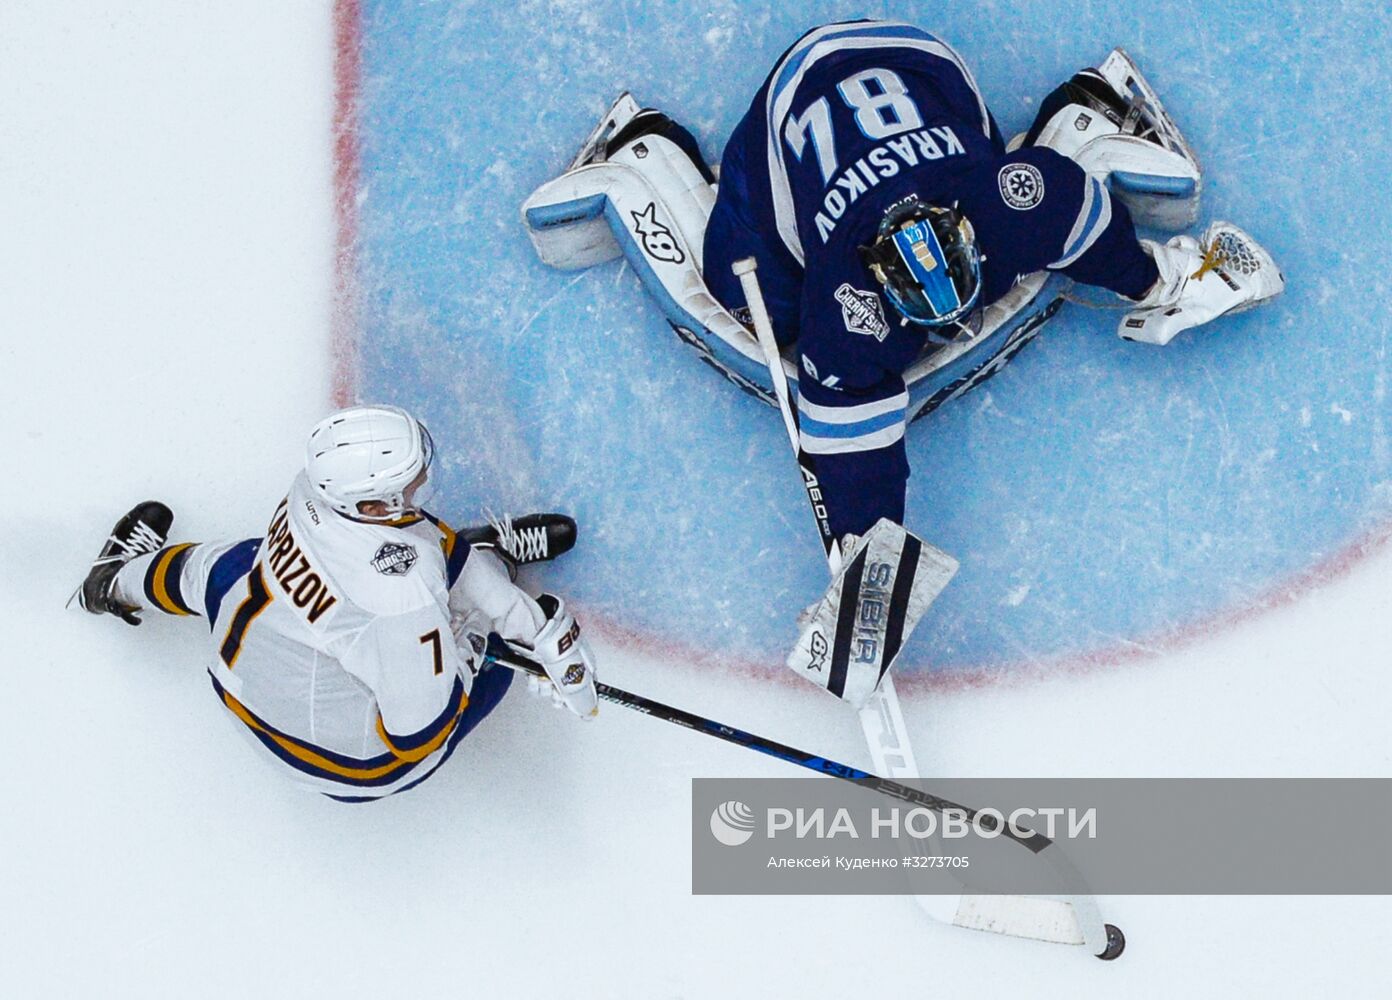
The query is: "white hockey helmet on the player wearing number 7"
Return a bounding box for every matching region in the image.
[305,405,434,521]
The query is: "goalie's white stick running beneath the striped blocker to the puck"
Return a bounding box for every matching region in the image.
[731,258,1125,958]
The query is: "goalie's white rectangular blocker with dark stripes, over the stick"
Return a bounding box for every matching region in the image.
[788,518,958,709]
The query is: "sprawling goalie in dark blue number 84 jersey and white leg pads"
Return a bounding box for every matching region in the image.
[522,21,1283,704]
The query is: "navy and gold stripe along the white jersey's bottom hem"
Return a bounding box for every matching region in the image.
[209,674,469,788]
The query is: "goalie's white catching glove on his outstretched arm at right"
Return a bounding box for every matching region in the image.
[1116,223,1286,347]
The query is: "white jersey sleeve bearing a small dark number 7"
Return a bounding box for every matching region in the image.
[341,607,470,747]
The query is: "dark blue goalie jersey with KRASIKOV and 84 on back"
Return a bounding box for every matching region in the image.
[704,21,1157,535]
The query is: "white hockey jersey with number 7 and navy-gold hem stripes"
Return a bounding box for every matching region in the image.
[209,474,544,798]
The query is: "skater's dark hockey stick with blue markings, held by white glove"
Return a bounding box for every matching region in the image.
[487,635,1126,961]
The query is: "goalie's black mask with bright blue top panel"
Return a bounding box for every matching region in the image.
[859,198,981,343]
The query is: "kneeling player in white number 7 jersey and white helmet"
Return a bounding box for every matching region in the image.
[77,405,599,802]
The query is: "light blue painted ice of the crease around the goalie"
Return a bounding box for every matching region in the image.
[358,0,1392,674]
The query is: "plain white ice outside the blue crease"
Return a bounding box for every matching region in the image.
[0,0,1392,1000]
